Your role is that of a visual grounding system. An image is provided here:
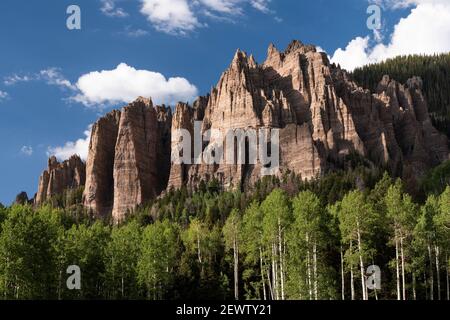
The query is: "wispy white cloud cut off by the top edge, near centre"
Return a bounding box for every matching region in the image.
[140,0,272,35]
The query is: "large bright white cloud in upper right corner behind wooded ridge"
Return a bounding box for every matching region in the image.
[332,0,450,70]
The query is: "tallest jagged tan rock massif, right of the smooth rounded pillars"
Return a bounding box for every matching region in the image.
[169,41,448,188]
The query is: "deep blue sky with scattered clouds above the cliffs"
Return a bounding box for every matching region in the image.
[0,0,450,204]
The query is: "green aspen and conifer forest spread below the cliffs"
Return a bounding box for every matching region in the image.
[0,171,450,299]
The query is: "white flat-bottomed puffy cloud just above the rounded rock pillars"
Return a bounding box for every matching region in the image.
[73,63,197,106]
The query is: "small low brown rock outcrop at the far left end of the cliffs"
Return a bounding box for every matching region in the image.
[34,155,86,205]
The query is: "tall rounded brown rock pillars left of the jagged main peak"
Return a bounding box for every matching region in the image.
[83,97,171,221]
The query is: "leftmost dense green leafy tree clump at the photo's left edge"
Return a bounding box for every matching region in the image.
[0,205,59,299]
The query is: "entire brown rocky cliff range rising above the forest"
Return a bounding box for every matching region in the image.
[36,41,449,221]
